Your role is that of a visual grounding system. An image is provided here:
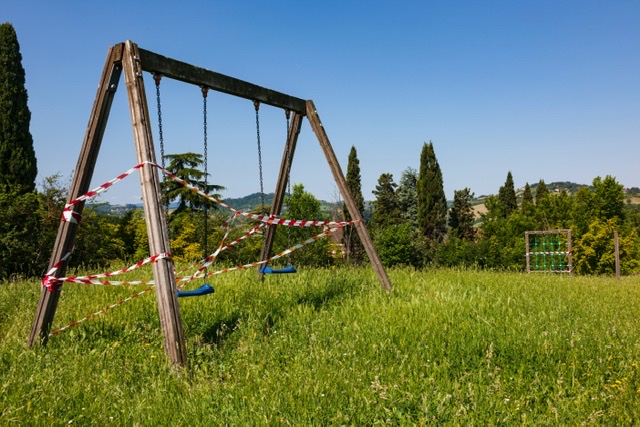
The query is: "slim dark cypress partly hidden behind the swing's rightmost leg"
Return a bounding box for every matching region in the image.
[342,146,364,264]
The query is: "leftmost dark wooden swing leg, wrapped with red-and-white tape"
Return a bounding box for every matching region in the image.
[28,43,124,347]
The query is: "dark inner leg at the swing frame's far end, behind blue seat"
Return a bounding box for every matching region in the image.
[260,113,303,270]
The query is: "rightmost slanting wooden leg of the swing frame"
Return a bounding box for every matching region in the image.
[307,100,393,292]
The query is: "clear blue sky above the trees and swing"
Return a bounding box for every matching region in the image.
[0,0,640,203]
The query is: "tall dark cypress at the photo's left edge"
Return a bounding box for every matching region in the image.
[0,23,38,194]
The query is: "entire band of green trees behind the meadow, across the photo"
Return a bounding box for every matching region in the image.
[0,23,640,280]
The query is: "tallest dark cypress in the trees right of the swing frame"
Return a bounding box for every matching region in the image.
[416,142,447,241]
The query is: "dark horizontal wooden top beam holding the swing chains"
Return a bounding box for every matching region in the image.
[139,49,306,115]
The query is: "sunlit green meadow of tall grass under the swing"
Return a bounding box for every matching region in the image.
[0,269,640,425]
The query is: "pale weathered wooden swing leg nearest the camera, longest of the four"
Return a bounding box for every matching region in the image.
[122,41,187,366]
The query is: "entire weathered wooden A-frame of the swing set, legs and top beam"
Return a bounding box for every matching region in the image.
[28,40,392,366]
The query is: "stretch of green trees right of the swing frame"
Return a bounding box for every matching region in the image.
[353,142,640,274]
